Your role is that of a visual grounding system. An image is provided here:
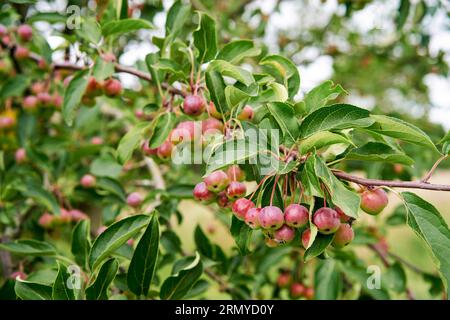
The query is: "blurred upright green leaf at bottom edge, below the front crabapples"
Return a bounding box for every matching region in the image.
[314,259,342,300]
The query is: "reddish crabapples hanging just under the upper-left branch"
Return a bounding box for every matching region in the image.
[78,74,123,106]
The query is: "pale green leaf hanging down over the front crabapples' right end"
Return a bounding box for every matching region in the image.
[314,155,361,219]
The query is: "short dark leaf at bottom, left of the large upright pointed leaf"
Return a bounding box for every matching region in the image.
[86,258,119,300]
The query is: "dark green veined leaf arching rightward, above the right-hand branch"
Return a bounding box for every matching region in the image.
[300,104,374,138]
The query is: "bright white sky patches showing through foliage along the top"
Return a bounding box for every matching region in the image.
[38,0,450,130]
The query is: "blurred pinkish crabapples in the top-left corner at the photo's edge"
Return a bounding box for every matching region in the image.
[0,24,33,60]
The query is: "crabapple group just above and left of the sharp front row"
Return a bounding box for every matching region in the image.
[193,165,247,208]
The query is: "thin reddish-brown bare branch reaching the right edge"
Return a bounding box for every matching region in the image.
[332,169,450,191]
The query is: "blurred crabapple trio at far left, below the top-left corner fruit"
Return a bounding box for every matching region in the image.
[22,82,63,111]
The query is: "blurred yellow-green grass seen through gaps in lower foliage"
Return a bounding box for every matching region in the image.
[168,170,450,299]
